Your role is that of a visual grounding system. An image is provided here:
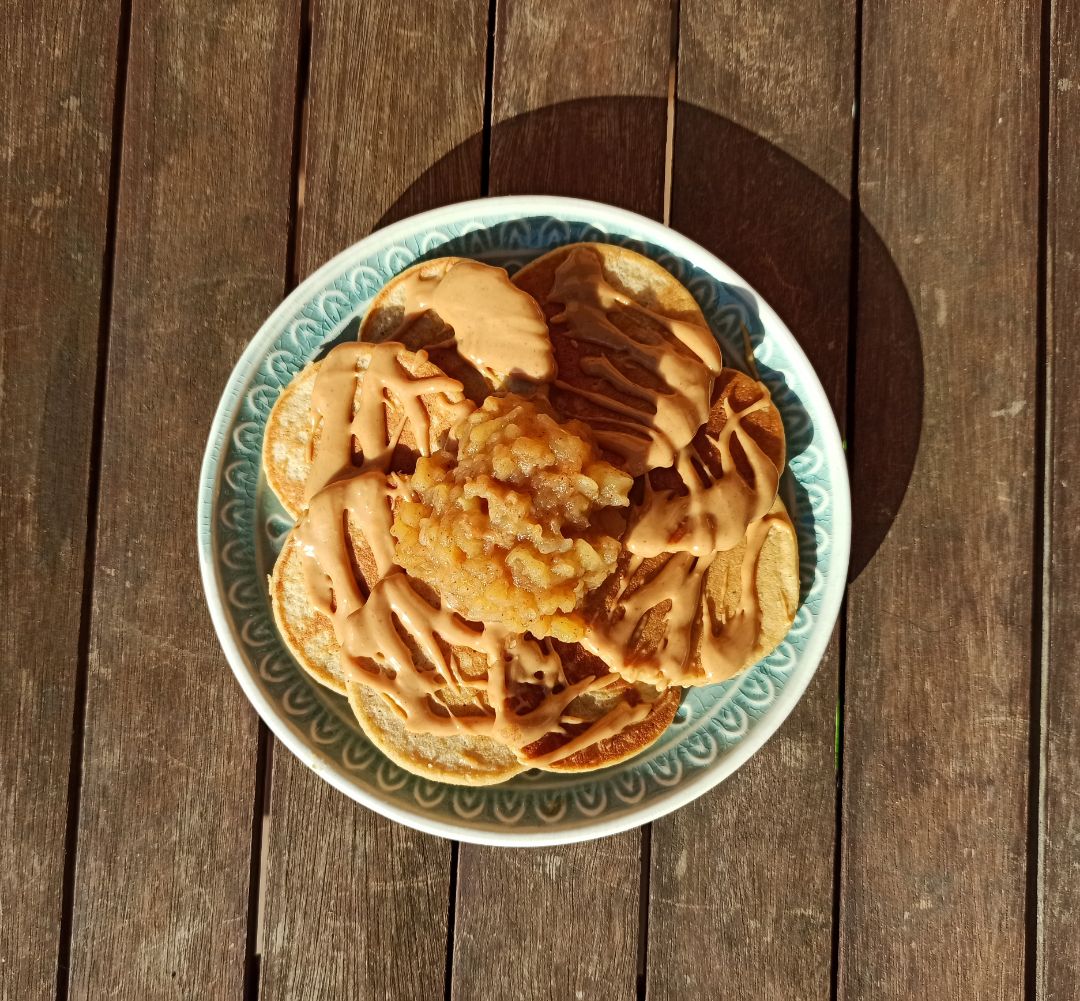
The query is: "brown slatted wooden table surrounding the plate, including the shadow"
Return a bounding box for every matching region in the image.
[0,0,1080,1001]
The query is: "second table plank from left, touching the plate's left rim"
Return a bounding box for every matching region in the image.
[70,0,298,999]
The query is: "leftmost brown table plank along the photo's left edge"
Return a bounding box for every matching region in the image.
[0,0,119,1001]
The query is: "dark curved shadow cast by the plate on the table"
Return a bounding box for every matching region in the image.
[378,97,923,580]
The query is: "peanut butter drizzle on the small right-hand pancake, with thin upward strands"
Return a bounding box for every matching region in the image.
[623,382,780,557]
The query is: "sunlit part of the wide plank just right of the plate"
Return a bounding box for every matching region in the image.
[839,0,1040,1001]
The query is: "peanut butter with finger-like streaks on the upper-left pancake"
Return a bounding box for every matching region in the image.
[305,341,465,502]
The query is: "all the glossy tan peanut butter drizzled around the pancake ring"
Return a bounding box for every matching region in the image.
[285,248,789,765]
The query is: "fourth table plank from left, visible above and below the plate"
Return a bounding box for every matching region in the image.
[453,7,671,1001]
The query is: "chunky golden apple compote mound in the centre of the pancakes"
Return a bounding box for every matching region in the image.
[392,395,633,641]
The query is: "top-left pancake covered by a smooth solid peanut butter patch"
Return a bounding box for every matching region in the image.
[359,257,554,405]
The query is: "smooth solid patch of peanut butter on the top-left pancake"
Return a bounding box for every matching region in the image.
[402,260,555,387]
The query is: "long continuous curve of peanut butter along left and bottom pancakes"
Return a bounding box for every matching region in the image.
[296,342,650,765]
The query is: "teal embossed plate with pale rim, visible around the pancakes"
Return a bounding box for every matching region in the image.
[198,195,851,846]
